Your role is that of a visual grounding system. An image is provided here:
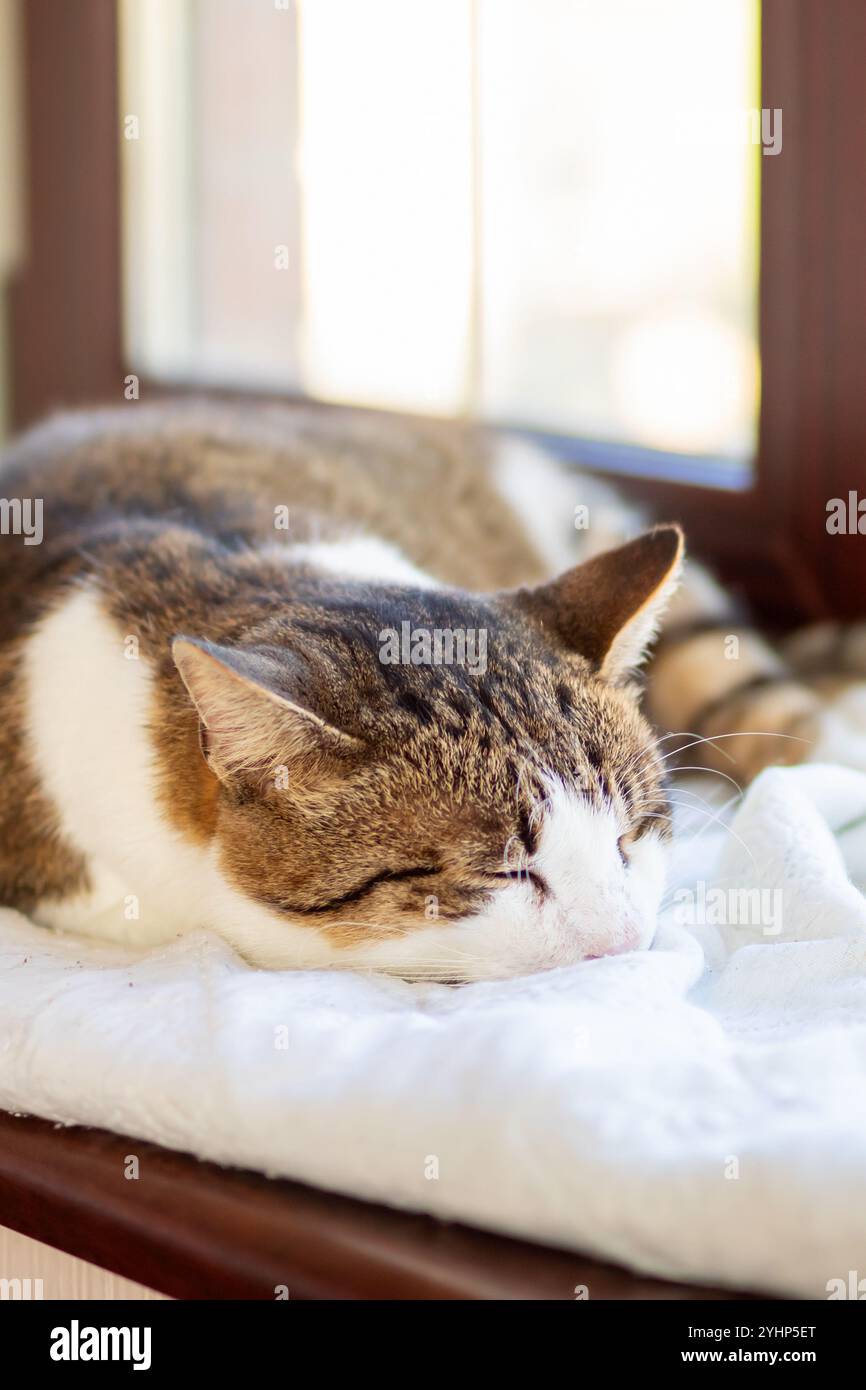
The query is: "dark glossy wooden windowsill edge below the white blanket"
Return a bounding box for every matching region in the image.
[0,1112,756,1300]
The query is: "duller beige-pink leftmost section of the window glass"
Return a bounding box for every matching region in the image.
[121,0,300,391]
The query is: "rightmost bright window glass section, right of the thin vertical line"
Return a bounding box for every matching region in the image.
[480,0,760,456]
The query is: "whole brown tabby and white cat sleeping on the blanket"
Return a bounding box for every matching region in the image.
[0,403,861,981]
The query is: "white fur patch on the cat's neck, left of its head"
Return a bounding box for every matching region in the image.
[25,589,221,944]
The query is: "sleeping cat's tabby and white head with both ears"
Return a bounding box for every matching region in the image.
[172,527,683,980]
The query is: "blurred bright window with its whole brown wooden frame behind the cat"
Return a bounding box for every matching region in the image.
[0,0,866,623]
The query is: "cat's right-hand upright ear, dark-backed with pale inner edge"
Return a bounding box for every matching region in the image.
[513,525,683,681]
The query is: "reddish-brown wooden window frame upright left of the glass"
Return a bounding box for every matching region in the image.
[10,0,124,427]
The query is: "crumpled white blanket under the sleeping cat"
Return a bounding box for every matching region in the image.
[0,766,866,1297]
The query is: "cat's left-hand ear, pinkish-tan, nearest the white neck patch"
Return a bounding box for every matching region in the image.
[171,637,364,788]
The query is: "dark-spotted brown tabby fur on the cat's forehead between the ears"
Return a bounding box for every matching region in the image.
[254,585,661,799]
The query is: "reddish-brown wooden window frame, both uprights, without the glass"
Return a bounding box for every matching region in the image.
[5,0,866,624]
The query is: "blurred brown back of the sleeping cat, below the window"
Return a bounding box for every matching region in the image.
[0,402,545,589]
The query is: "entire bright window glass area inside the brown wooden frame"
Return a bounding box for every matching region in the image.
[122,0,756,459]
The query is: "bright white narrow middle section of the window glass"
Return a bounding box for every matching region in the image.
[300,0,473,413]
